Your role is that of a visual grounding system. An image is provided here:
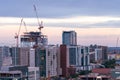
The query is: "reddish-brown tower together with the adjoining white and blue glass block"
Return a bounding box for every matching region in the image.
[60,45,90,77]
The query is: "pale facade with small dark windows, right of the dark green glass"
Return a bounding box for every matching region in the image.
[46,45,58,77]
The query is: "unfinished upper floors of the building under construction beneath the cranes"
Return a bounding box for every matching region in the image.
[20,32,48,47]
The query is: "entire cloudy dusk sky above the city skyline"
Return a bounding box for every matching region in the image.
[0,0,120,46]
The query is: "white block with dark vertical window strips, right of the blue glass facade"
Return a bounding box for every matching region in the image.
[76,46,90,70]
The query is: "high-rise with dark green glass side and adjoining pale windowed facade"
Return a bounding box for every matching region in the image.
[35,45,58,77]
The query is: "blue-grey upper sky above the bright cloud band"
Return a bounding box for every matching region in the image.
[0,0,120,18]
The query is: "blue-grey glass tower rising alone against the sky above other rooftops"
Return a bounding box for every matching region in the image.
[62,31,77,45]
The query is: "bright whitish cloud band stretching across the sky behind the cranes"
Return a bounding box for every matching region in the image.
[0,16,120,28]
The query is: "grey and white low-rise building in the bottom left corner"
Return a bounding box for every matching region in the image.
[0,66,40,80]
